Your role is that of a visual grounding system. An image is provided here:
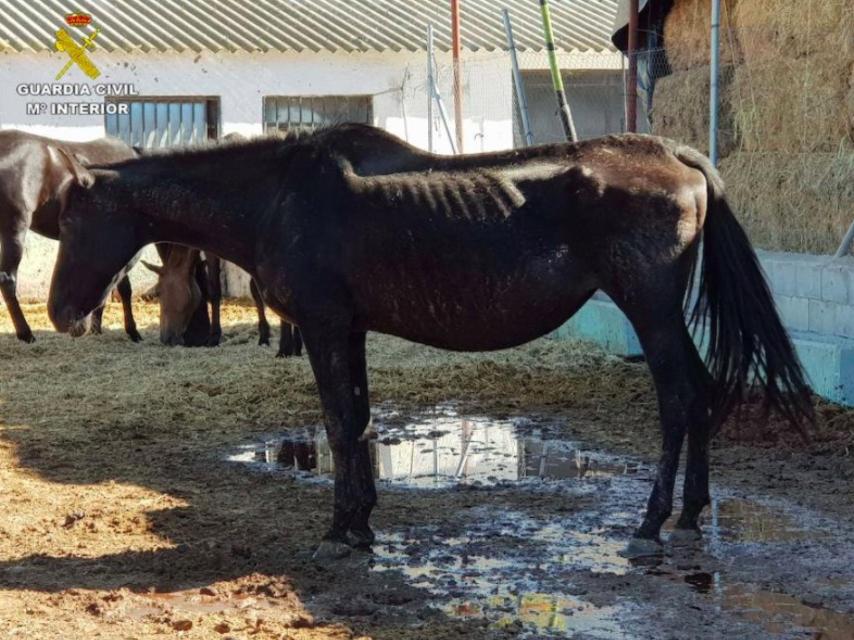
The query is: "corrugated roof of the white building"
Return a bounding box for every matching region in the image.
[0,0,619,52]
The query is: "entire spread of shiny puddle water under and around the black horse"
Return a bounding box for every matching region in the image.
[229,407,854,640]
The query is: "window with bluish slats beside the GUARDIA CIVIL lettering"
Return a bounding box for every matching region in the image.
[104,97,219,149]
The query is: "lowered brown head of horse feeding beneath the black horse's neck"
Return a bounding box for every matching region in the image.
[142,245,208,346]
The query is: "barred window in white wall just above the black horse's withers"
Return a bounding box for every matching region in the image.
[264,96,373,133]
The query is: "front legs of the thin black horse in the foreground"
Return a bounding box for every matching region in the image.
[301,319,376,559]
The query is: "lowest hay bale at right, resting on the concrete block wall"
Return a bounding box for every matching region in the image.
[720,151,854,253]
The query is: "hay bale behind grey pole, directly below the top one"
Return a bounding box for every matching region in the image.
[650,67,736,157]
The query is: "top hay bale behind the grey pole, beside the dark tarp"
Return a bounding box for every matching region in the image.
[664,0,745,72]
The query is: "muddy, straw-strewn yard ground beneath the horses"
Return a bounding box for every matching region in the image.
[0,303,854,640]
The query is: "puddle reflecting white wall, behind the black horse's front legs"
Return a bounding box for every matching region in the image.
[229,407,638,488]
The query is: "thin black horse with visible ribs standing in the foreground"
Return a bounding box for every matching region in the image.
[48,125,813,557]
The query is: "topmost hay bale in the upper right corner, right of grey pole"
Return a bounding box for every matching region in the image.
[733,0,854,61]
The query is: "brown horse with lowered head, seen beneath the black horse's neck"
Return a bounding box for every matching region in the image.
[141,243,302,357]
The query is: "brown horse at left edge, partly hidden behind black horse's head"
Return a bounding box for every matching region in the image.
[0,131,141,342]
